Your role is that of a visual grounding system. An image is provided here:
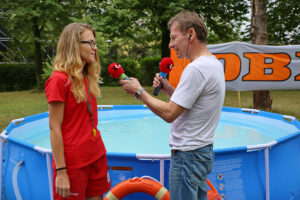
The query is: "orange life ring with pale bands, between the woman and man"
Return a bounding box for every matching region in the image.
[103,178,170,200]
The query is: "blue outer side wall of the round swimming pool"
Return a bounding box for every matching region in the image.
[2,106,300,200]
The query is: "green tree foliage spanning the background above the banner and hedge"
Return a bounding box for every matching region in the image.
[0,0,300,80]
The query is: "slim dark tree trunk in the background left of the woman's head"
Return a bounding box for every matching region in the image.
[33,18,43,89]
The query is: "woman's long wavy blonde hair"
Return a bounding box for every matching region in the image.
[54,23,101,103]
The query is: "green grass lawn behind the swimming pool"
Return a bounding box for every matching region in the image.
[0,86,300,132]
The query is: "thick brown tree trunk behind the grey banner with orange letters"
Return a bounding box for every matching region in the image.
[250,0,272,110]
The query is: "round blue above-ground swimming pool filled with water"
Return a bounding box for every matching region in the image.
[1,106,300,200]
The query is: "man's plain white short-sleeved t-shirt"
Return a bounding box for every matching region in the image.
[169,56,225,151]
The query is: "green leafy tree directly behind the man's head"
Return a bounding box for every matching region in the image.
[89,0,249,57]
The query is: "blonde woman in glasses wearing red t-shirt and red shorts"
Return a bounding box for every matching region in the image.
[45,23,110,200]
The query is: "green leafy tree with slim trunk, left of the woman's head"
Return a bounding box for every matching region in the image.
[0,0,82,88]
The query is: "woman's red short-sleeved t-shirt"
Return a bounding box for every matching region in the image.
[45,71,106,169]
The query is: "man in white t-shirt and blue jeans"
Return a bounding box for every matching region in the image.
[120,11,225,200]
